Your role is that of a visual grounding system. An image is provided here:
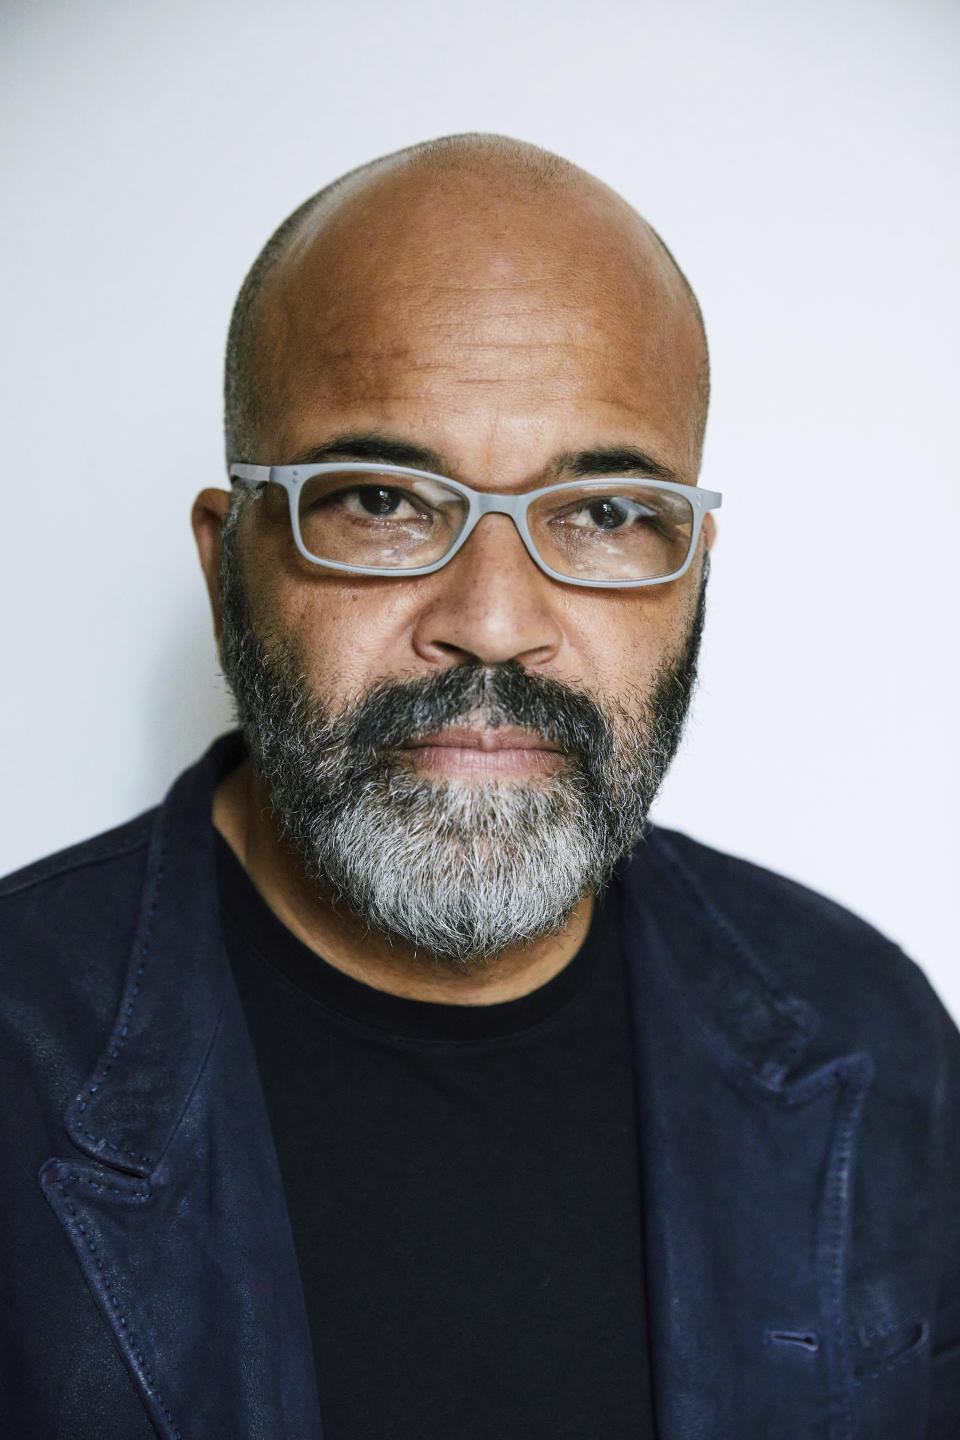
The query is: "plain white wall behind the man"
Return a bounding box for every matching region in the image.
[0,0,960,1015]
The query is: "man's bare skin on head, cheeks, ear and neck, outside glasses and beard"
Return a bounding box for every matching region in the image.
[193,147,714,1004]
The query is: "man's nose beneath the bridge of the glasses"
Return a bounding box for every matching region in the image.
[413,514,563,668]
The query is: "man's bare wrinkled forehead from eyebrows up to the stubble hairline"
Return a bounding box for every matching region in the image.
[255,167,702,468]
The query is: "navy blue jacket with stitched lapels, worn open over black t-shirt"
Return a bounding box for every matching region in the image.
[0,737,960,1440]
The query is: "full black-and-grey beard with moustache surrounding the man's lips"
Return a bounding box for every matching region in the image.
[220,507,708,973]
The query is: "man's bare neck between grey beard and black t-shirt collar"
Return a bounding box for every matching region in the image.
[213,760,593,1005]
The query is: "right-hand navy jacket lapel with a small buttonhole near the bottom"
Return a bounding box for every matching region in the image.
[625,831,872,1440]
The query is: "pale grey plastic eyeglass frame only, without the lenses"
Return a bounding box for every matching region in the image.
[227,461,723,590]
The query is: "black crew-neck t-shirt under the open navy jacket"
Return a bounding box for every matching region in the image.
[217,837,653,1440]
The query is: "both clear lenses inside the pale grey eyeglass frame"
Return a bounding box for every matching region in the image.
[298,469,694,580]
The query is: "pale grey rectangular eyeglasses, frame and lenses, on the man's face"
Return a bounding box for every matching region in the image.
[227,462,721,588]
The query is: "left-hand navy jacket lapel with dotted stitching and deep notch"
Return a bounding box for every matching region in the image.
[40,737,321,1440]
